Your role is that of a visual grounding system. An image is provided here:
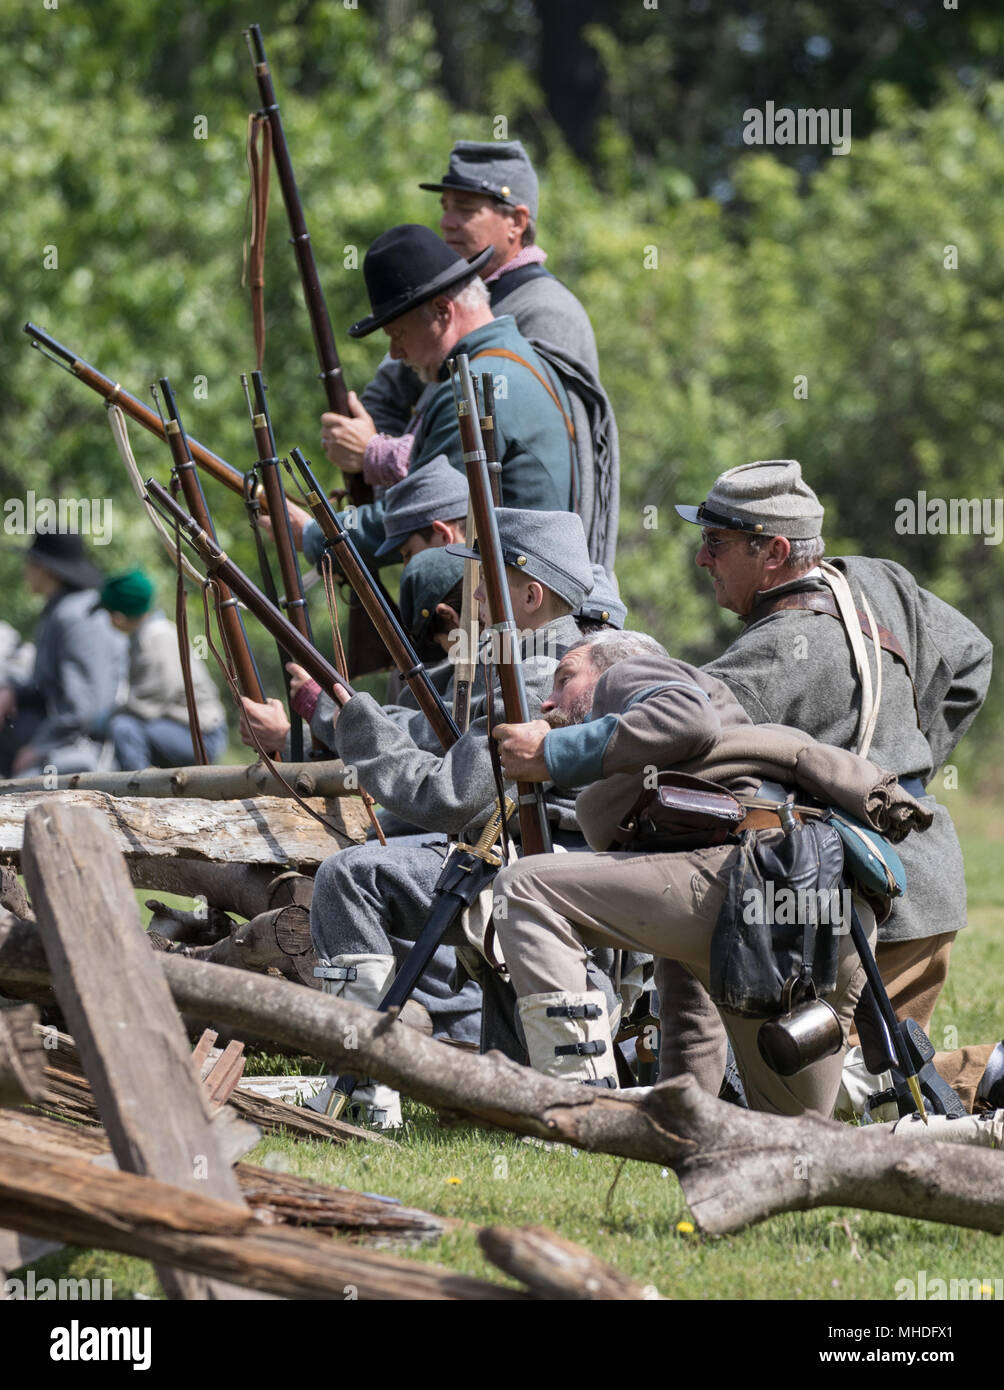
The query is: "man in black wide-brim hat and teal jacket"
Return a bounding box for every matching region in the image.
[280,225,577,567]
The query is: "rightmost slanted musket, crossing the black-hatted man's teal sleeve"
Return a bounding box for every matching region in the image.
[289,449,460,749]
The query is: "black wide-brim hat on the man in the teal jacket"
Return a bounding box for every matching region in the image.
[349,222,494,338]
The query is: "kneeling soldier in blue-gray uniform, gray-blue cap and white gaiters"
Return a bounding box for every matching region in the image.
[245,507,651,1113]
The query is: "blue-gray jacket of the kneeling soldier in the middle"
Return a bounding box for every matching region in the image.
[310,617,581,837]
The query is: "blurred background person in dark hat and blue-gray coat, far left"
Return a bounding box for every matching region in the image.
[0,531,125,777]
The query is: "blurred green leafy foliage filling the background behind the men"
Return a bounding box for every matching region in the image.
[0,0,1004,748]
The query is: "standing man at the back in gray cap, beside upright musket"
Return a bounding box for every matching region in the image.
[321,140,619,571]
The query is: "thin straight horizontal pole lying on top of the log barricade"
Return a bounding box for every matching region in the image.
[0,760,351,801]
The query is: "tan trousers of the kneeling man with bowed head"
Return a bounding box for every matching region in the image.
[495,845,875,1115]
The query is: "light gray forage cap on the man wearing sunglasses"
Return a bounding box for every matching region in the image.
[676,459,823,541]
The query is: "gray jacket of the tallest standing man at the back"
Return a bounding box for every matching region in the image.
[362,262,620,574]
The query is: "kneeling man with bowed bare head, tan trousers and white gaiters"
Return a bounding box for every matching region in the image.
[495,649,930,1115]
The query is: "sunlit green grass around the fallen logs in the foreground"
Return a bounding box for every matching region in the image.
[13,794,1004,1300]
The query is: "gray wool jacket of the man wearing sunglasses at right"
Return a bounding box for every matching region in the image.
[705,556,991,941]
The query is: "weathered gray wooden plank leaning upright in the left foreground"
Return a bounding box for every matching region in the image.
[22,799,254,1298]
